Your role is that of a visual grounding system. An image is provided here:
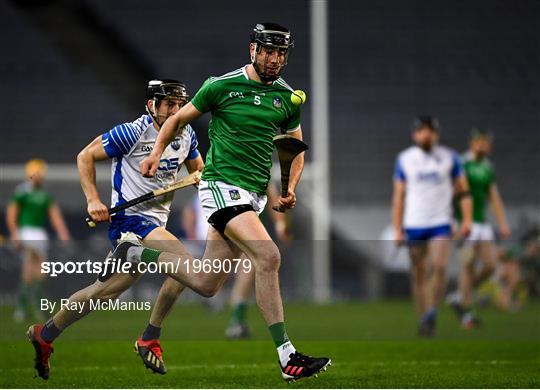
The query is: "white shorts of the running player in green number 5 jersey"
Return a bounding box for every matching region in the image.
[199,180,266,221]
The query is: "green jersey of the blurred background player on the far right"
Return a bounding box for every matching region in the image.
[457,152,495,223]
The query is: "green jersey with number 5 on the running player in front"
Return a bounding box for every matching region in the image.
[191,67,300,195]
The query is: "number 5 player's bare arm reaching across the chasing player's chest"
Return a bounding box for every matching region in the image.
[140,102,203,177]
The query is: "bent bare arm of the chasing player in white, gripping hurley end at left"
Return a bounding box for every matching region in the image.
[77,136,110,222]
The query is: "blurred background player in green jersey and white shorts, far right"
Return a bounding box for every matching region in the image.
[452,129,510,328]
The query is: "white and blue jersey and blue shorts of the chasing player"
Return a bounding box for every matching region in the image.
[101,115,199,240]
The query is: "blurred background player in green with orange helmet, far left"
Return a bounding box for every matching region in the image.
[6,159,70,322]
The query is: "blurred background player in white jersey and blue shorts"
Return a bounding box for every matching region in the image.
[392,116,472,336]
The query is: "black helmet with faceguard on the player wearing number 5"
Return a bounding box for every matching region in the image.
[250,23,294,83]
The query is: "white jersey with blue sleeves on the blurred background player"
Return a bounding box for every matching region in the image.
[394,145,463,232]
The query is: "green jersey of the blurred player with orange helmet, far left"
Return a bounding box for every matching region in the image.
[11,183,53,228]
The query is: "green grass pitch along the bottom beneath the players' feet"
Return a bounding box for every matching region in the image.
[0,302,540,388]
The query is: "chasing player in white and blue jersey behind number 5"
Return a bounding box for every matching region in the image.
[28,80,204,379]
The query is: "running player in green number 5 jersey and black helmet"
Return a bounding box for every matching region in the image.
[140,23,330,380]
